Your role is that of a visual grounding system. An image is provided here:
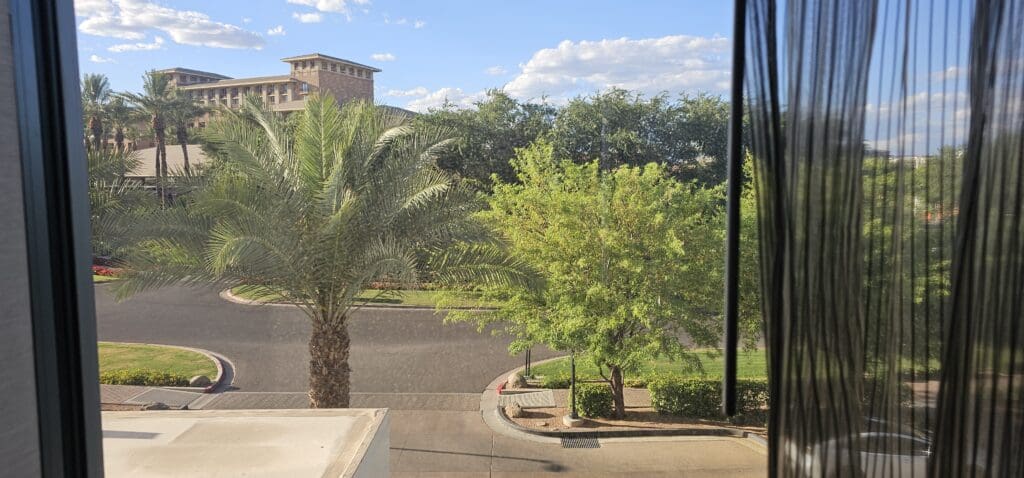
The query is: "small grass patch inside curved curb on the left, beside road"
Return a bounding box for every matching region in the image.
[99,342,217,380]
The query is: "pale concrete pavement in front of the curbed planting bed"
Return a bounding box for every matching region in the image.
[390,410,767,478]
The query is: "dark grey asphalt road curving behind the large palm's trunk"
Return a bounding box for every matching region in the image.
[96,285,554,393]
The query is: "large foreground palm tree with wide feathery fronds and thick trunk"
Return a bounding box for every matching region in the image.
[117,95,497,407]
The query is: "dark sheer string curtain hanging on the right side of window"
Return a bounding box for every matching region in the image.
[744,0,1024,477]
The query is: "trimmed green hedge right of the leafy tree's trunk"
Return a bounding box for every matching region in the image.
[647,378,768,425]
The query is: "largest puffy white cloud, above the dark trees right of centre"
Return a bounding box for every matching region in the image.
[505,35,730,101]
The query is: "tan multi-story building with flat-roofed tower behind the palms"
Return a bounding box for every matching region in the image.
[160,53,380,127]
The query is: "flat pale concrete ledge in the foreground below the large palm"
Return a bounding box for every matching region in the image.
[102,408,390,478]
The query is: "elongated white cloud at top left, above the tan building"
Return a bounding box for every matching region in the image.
[75,0,263,49]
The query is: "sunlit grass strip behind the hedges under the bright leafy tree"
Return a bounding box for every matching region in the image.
[530,349,768,380]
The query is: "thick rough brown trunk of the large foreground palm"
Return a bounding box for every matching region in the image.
[309,317,351,408]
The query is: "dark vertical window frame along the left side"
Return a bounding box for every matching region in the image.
[9,0,103,478]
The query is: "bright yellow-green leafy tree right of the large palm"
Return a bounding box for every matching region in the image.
[449,141,724,417]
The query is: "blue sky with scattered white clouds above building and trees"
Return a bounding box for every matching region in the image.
[75,0,731,111]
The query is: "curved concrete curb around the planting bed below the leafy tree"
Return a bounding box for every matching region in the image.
[480,356,767,447]
